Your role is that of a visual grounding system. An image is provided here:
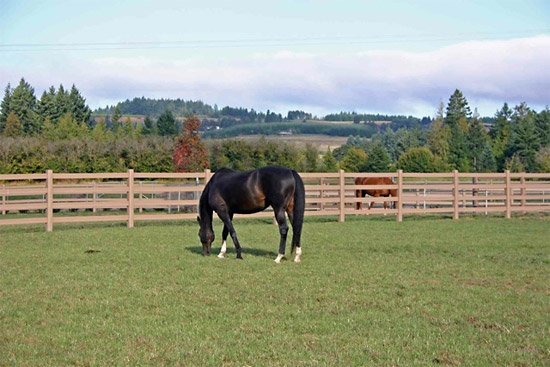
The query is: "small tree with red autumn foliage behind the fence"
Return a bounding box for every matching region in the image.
[172,116,210,172]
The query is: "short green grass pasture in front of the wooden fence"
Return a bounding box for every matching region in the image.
[0,217,550,366]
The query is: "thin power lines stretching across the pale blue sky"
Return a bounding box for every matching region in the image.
[0,29,550,52]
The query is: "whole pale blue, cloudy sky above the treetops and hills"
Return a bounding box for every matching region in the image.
[0,0,550,117]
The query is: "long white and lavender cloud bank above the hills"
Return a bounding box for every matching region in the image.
[3,36,550,115]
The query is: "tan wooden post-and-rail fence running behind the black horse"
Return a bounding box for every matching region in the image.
[0,169,550,231]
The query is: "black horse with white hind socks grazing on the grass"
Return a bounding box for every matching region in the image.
[197,166,305,263]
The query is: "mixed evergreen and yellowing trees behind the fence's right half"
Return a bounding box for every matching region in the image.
[334,90,550,172]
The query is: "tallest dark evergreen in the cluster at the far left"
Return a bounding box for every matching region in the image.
[10,78,41,135]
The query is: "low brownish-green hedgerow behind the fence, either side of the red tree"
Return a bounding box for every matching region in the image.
[0,136,338,174]
